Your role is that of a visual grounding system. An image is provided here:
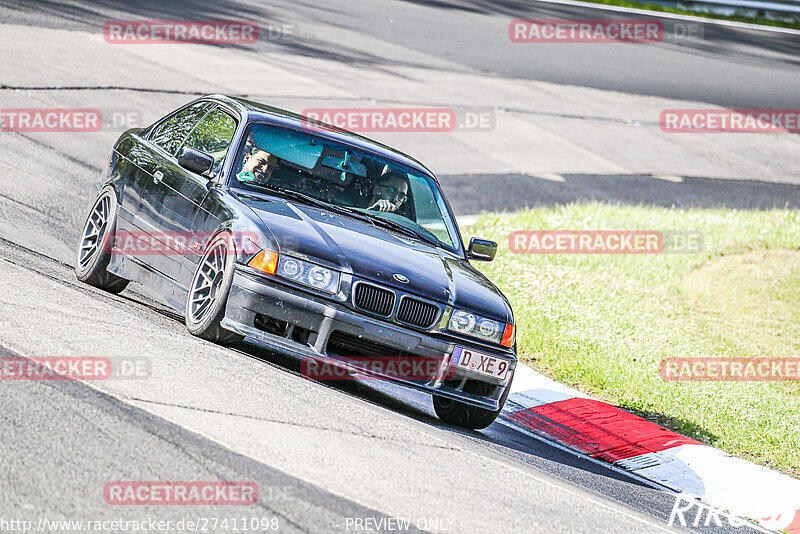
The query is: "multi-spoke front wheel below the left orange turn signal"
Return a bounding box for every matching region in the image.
[184,232,244,345]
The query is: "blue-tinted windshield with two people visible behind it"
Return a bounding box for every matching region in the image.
[230,123,461,252]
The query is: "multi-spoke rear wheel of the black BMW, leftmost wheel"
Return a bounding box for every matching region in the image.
[75,189,129,294]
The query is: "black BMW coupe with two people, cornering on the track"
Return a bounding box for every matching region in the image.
[75,95,517,429]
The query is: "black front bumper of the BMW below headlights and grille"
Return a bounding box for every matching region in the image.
[222,265,516,411]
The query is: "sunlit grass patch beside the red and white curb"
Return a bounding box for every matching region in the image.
[467,203,800,477]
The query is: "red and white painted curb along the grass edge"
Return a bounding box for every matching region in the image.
[500,365,800,534]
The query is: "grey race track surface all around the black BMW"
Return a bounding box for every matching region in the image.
[0,0,800,534]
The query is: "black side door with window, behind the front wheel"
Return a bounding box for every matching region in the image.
[142,107,236,288]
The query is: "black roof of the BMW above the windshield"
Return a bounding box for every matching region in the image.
[199,94,436,180]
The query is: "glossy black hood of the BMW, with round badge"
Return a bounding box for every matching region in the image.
[239,194,512,322]
